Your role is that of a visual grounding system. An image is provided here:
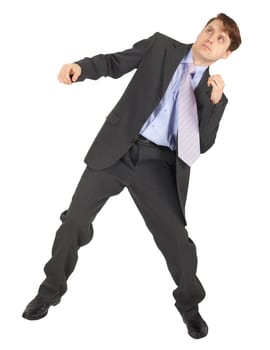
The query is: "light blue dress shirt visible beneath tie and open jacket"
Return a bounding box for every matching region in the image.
[140,49,207,151]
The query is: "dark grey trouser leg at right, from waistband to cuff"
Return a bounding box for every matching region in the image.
[127,145,205,316]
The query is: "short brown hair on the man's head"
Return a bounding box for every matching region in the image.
[206,13,242,51]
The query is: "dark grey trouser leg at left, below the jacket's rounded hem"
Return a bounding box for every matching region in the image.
[38,160,129,301]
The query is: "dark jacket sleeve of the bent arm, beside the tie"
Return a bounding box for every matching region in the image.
[199,94,228,153]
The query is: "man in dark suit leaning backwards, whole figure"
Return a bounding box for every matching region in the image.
[23,14,241,339]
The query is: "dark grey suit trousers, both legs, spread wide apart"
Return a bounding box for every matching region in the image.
[38,139,205,317]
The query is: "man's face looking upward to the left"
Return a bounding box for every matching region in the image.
[192,19,231,65]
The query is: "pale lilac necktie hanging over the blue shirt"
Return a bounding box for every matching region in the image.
[178,63,200,166]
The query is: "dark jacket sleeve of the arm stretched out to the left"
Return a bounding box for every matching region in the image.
[74,32,158,81]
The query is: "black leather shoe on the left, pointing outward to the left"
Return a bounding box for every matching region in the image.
[22,295,61,320]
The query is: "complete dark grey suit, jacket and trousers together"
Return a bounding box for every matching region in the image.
[36,32,227,314]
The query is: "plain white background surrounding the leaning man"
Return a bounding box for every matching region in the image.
[0,0,270,350]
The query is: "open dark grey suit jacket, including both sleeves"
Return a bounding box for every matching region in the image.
[75,32,228,224]
